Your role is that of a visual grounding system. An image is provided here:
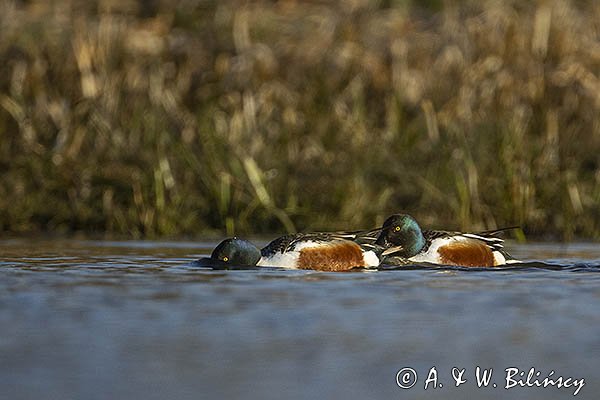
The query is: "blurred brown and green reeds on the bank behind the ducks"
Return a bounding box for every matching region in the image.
[0,0,600,239]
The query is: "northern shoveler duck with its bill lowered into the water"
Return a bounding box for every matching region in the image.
[211,229,383,271]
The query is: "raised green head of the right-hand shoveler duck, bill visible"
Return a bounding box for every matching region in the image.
[376,214,425,258]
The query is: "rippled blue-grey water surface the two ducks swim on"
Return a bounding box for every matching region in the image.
[0,240,600,400]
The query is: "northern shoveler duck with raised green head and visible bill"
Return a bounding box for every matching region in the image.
[375,214,518,267]
